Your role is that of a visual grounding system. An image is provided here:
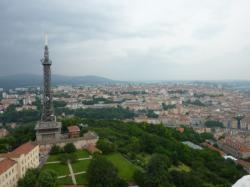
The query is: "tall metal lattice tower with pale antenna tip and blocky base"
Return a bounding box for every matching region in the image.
[35,35,61,142]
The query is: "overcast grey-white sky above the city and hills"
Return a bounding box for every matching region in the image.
[0,0,250,80]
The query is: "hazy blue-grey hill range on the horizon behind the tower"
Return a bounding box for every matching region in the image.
[0,74,116,89]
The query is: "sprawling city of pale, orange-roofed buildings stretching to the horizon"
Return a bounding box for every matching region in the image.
[0,82,250,186]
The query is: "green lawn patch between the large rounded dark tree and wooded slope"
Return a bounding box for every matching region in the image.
[105,153,137,182]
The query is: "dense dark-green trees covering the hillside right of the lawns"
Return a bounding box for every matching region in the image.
[86,121,246,187]
